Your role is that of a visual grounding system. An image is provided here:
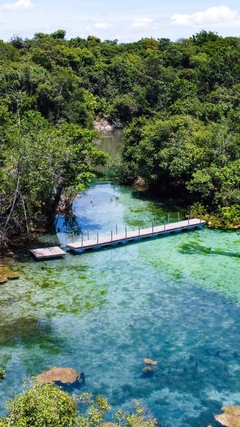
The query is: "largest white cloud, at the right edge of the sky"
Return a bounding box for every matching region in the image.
[171,6,240,27]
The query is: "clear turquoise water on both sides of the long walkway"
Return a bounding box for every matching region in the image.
[0,183,240,427]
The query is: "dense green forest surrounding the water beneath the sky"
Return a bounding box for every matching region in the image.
[0,30,240,249]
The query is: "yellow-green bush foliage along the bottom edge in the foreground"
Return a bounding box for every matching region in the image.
[0,382,156,427]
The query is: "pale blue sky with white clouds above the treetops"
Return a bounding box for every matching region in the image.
[0,0,240,42]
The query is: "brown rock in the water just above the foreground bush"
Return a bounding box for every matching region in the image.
[36,366,84,384]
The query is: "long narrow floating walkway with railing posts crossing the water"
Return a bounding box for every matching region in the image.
[66,218,206,252]
